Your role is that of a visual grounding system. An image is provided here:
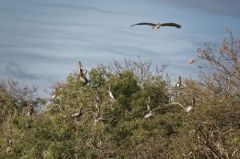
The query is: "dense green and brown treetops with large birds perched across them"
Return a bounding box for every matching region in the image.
[0,31,240,159]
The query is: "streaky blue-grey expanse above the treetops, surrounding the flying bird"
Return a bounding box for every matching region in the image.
[0,0,240,96]
